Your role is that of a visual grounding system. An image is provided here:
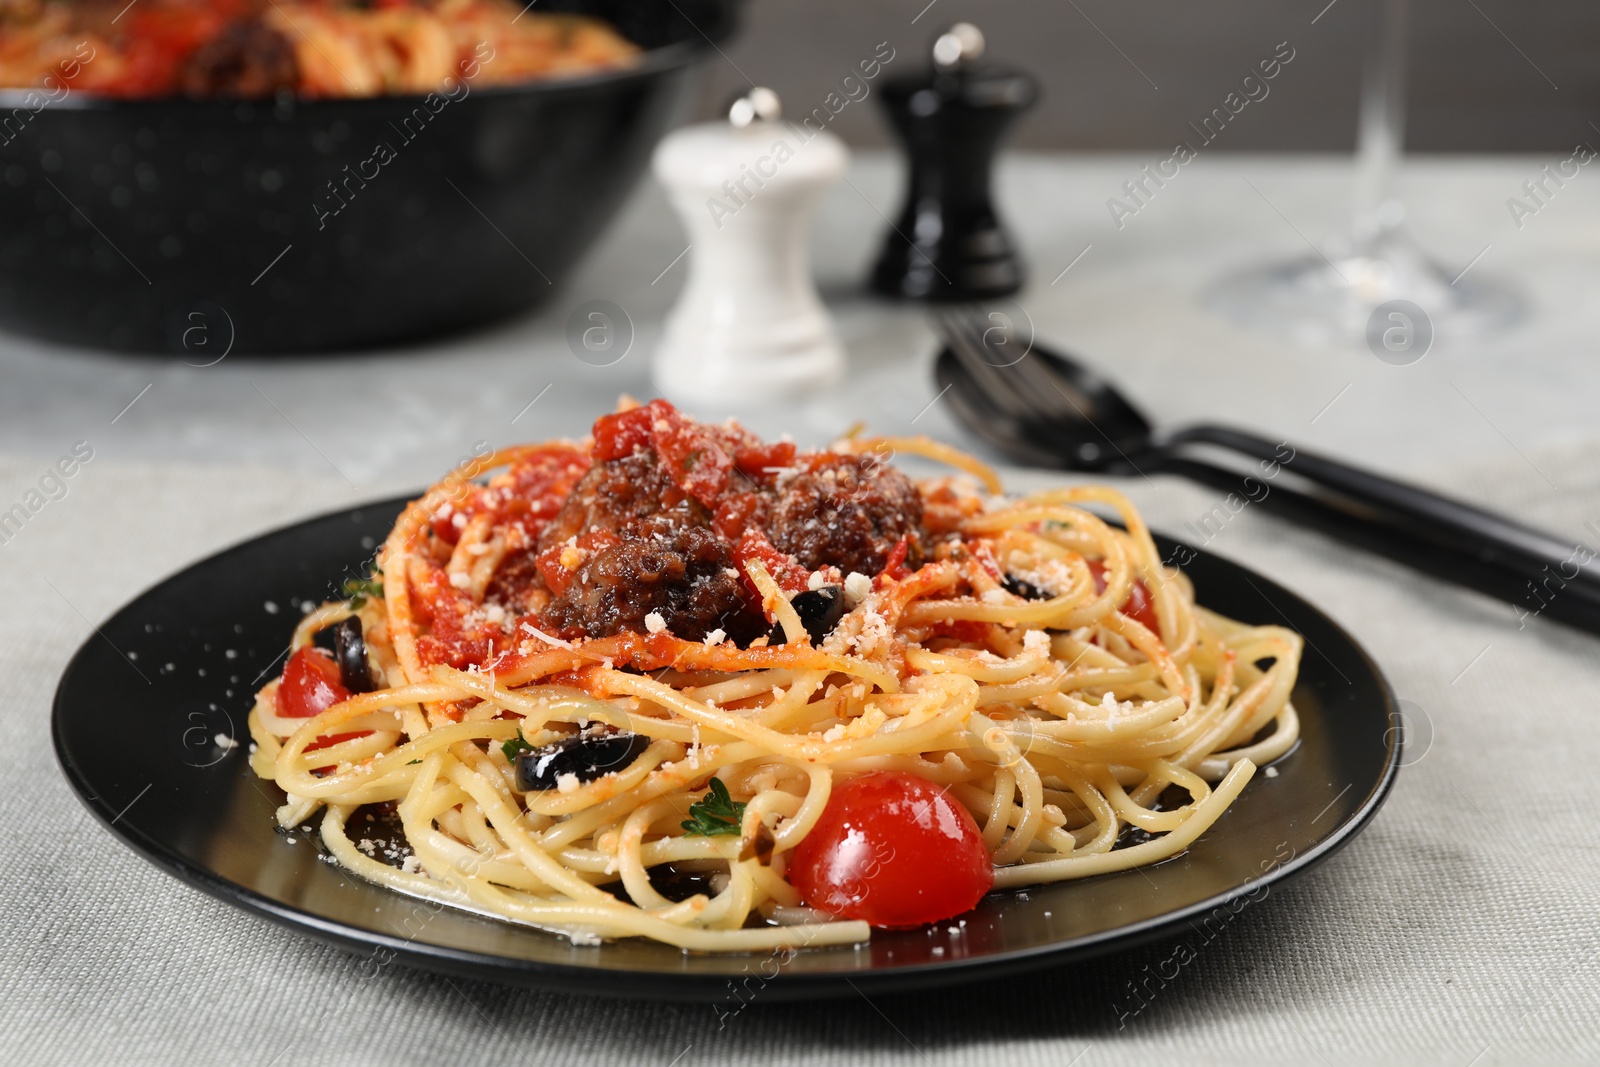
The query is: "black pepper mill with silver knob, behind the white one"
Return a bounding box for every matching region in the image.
[872,22,1038,301]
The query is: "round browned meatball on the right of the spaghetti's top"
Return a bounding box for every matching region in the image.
[765,454,922,574]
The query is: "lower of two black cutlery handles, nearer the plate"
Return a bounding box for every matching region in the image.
[1155,456,1600,633]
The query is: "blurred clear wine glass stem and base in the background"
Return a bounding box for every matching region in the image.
[1208,0,1523,344]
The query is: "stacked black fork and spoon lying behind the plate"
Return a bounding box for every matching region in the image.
[933,309,1600,632]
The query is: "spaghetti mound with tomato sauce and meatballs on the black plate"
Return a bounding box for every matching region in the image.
[250,402,1301,952]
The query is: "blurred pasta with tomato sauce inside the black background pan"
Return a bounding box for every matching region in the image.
[0,0,638,98]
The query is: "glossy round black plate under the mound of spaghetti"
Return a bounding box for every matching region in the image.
[54,501,1400,1003]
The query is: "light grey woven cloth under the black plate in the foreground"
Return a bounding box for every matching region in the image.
[0,435,1600,1067]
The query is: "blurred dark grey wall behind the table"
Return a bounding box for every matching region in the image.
[684,0,1600,152]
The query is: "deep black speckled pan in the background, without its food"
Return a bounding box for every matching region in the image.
[0,0,738,355]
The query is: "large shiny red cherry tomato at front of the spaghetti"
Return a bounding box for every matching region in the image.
[789,771,995,929]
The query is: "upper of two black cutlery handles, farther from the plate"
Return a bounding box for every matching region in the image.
[1162,426,1600,591]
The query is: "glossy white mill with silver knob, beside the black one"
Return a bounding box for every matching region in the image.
[653,88,850,406]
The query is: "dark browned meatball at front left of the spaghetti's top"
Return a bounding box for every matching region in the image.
[541,511,766,645]
